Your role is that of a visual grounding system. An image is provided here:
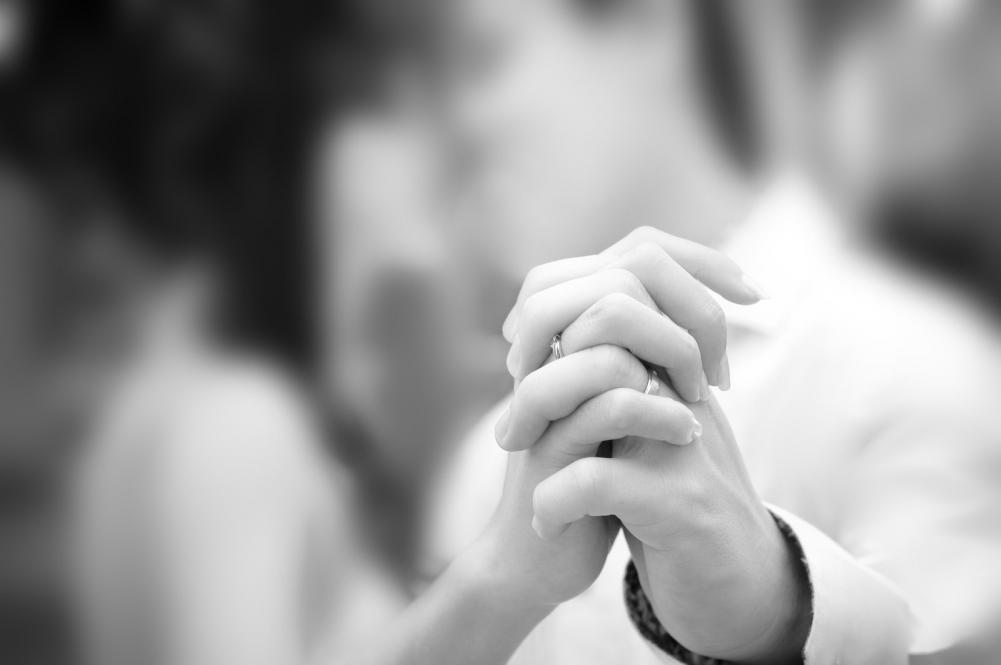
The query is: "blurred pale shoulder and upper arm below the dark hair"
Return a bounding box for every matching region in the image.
[75,338,360,665]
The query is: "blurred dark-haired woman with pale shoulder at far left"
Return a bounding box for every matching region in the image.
[2,2,384,665]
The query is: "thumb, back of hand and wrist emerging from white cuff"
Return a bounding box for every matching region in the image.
[535,390,810,663]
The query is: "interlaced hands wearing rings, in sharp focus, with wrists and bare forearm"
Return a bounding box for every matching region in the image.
[371,229,809,664]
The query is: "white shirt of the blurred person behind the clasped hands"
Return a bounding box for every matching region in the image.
[432,179,1001,665]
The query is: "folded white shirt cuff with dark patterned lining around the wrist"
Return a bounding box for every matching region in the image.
[625,507,911,665]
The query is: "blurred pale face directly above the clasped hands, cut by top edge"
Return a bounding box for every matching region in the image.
[446,0,685,278]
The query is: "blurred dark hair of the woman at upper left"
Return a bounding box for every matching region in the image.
[0,0,364,364]
